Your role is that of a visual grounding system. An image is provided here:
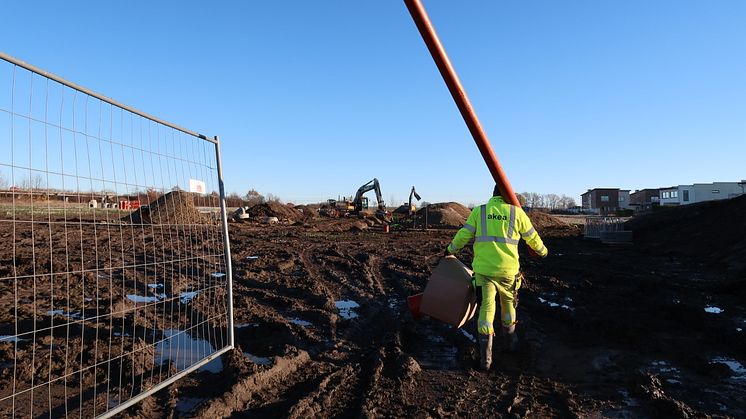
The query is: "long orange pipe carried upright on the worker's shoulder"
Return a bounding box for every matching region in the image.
[404,0,521,206]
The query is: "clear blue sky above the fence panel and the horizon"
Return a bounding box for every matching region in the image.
[0,0,746,204]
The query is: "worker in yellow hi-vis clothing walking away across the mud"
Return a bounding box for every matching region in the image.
[444,186,549,370]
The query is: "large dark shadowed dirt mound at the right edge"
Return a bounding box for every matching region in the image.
[627,196,746,273]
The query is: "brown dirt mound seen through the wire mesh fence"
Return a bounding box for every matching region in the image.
[122,191,210,224]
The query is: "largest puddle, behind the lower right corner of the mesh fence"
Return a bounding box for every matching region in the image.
[155,329,223,373]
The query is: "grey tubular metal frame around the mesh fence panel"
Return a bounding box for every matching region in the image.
[0,51,235,418]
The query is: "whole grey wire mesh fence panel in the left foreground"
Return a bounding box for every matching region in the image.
[0,53,233,417]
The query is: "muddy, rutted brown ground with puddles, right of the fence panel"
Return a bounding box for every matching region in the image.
[126,213,746,418]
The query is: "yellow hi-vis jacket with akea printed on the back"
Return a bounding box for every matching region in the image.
[448,196,548,278]
